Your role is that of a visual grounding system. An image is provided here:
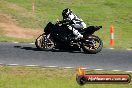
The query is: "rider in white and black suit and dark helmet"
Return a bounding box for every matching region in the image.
[62,8,86,39]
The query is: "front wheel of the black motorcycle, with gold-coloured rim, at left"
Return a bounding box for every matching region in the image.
[35,34,54,51]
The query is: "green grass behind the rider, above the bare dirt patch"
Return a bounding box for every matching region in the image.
[0,0,132,48]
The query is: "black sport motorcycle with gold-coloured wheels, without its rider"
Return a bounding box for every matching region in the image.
[35,22,103,54]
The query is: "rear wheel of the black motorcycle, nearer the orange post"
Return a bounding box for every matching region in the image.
[82,35,103,54]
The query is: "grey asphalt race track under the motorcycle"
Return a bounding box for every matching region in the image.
[0,42,132,71]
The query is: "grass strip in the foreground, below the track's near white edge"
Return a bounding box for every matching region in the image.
[0,66,132,88]
